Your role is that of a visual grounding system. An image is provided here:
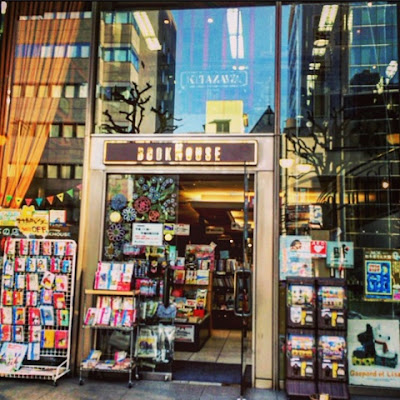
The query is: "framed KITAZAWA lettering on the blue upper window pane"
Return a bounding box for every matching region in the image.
[180,71,248,89]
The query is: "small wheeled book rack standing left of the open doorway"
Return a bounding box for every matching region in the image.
[79,289,137,388]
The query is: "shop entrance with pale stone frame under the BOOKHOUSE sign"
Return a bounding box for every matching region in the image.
[79,136,274,387]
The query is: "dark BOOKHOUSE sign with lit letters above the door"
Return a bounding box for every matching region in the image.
[104,140,257,165]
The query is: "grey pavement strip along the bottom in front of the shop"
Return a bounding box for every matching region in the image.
[0,377,394,400]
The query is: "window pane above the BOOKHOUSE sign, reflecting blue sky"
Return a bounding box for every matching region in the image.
[95,5,275,133]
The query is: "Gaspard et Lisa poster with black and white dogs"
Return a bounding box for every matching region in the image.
[347,319,400,388]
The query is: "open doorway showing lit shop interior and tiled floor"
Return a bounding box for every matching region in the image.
[173,174,254,384]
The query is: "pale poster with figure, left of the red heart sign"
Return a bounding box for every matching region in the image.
[279,235,313,280]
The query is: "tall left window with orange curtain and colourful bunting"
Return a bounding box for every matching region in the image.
[0,1,91,243]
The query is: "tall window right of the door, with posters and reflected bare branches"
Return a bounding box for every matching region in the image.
[280,2,400,387]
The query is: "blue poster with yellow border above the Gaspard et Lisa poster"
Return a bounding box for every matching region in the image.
[364,249,400,301]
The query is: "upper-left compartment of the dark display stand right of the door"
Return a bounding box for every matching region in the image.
[286,278,316,328]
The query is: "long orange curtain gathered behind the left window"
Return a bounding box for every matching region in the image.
[0,1,83,208]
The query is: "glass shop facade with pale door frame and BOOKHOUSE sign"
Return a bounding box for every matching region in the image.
[0,1,400,390]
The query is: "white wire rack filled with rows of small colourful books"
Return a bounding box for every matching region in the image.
[0,239,76,385]
